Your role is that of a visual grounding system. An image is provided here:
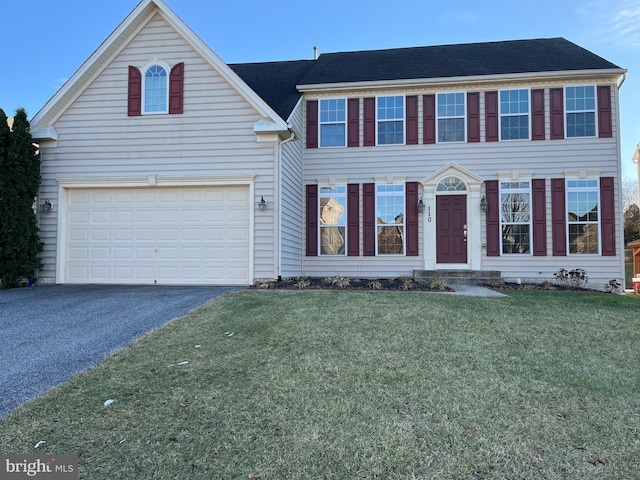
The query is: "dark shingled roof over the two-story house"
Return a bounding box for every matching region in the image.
[230,38,621,120]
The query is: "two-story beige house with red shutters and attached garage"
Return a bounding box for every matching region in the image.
[32,0,626,287]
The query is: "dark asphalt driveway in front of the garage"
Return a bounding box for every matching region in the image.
[0,285,242,417]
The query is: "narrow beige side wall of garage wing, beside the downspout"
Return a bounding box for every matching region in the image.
[280,102,304,278]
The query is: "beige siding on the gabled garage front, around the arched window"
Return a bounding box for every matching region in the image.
[40,14,277,280]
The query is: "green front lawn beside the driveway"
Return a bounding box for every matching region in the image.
[0,291,640,480]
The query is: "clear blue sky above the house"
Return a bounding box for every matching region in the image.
[0,0,640,178]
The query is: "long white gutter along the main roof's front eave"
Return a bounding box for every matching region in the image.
[296,68,627,93]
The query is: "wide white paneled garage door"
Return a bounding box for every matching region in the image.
[65,186,250,285]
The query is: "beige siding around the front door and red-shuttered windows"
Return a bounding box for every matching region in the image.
[303,80,623,288]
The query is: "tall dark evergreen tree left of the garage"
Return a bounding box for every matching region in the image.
[0,109,42,288]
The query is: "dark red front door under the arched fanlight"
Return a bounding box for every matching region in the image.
[436,195,467,263]
